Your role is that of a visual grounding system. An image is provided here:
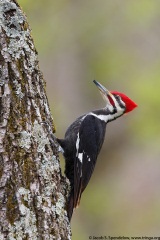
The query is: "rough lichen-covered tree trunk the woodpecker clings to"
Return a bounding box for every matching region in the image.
[0,0,71,240]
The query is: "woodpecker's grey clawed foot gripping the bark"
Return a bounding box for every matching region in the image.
[41,121,64,154]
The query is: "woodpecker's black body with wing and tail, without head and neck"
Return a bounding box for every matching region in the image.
[57,110,107,220]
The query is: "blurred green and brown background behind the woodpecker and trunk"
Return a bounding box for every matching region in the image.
[18,0,160,240]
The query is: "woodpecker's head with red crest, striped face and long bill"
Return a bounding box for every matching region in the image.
[93,80,137,115]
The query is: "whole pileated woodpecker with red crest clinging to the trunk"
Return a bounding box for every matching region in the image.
[57,80,137,220]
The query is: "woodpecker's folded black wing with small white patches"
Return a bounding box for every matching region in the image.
[74,115,106,208]
